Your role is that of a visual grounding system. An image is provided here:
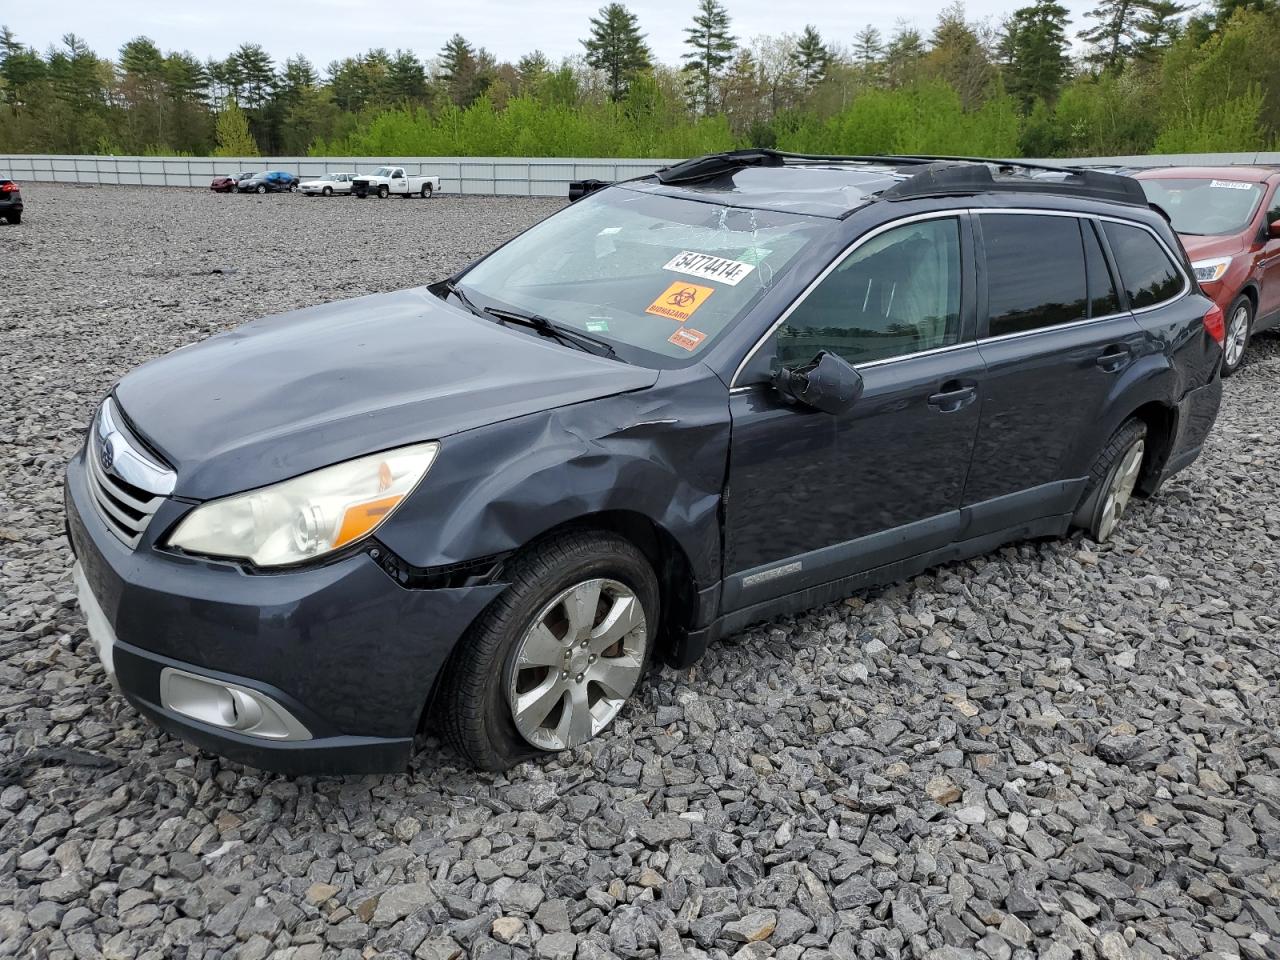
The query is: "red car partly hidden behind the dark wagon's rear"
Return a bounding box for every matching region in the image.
[1134,166,1280,376]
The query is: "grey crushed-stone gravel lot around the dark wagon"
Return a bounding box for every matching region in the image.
[0,184,1280,960]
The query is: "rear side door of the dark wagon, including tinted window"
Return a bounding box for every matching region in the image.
[964,210,1144,539]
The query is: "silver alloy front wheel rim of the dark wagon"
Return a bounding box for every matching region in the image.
[507,580,648,750]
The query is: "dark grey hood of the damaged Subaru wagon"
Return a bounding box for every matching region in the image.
[115,288,658,499]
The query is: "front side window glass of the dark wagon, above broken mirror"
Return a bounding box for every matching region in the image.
[774,218,960,364]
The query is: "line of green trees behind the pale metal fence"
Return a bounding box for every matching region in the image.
[0,0,1280,157]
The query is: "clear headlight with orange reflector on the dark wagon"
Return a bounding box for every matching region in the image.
[169,443,440,567]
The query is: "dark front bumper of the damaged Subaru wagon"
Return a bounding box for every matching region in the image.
[65,452,503,774]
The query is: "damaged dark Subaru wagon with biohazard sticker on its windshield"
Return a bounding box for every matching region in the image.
[67,151,1222,772]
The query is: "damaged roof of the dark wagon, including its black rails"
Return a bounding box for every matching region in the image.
[614,150,1148,219]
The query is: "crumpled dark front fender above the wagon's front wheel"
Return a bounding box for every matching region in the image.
[378,367,730,588]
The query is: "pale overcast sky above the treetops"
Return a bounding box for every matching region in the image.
[0,0,1092,69]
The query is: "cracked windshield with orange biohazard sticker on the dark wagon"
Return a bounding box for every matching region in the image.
[461,188,829,366]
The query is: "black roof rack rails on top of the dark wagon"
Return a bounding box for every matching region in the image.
[654,148,1147,206]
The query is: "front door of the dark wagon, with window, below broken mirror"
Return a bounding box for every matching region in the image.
[722,214,983,612]
